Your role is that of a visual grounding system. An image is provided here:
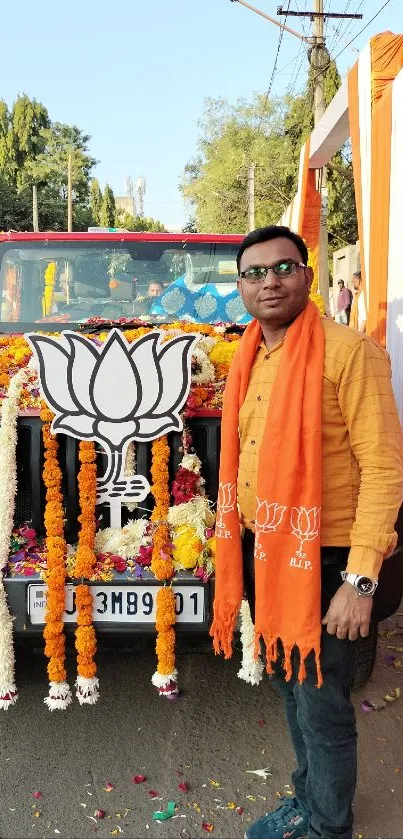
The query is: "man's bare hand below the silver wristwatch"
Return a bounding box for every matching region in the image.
[322,583,373,641]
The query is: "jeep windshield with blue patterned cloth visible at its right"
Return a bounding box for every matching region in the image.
[0,241,246,329]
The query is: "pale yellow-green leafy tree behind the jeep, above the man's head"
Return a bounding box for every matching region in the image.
[182,96,295,233]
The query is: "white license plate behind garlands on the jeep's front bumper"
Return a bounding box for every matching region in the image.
[28,583,205,624]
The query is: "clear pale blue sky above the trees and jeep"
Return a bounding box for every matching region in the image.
[0,0,403,230]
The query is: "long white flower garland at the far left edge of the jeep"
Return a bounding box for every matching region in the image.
[0,364,33,710]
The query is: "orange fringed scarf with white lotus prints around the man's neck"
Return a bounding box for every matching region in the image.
[210,301,324,687]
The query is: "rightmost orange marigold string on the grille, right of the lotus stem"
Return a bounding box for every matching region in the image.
[151,436,178,696]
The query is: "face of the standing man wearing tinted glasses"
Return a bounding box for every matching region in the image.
[238,236,313,328]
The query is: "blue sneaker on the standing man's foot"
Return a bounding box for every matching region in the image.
[245,797,309,839]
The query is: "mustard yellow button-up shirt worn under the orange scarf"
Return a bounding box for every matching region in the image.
[238,318,403,579]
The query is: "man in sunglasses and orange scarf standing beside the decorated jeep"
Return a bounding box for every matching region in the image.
[211,227,403,839]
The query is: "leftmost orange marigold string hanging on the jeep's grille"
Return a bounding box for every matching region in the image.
[41,405,72,711]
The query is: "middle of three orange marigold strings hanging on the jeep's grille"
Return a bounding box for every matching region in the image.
[74,440,99,705]
